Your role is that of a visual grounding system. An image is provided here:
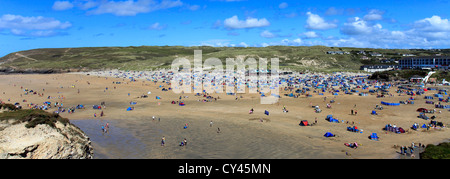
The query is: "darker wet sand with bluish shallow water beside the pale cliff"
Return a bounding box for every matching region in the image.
[71,117,345,159]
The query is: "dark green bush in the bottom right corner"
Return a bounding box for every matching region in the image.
[420,142,450,159]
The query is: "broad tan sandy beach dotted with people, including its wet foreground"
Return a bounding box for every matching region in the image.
[0,74,450,159]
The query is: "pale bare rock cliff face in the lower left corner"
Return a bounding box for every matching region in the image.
[0,114,93,159]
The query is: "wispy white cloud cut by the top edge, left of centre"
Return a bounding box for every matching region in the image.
[88,0,183,16]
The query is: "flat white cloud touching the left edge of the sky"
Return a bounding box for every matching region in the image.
[0,14,72,37]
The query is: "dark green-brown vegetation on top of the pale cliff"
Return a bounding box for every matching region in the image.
[0,104,69,128]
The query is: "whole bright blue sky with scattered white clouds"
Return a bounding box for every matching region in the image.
[0,0,450,56]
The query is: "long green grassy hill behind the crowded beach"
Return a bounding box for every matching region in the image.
[0,46,446,72]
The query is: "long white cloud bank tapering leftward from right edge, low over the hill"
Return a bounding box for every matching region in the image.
[261,16,450,48]
